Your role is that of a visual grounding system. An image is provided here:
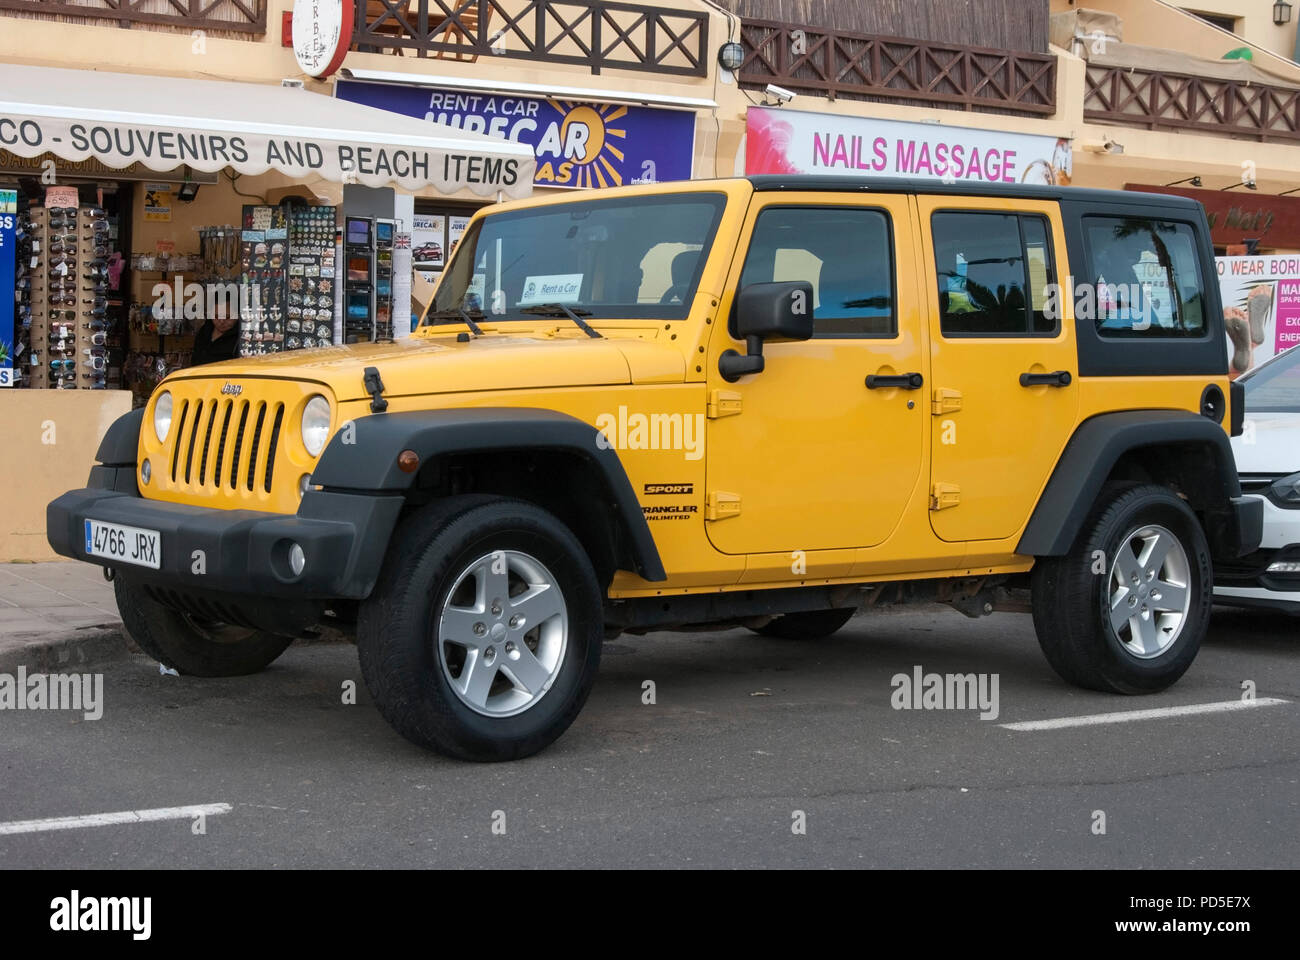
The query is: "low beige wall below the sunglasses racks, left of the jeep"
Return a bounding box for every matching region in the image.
[0,390,131,562]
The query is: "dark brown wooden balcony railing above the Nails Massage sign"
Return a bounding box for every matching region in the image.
[740,20,1056,114]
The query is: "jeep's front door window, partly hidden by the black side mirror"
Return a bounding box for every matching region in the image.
[740,207,897,337]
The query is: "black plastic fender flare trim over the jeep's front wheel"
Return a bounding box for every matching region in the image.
[312,407,668,581]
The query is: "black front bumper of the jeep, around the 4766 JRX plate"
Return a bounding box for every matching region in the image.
[46,488,403,600]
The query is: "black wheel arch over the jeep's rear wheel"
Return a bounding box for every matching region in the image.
[1017,410,1262,557]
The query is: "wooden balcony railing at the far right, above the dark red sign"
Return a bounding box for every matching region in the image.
[1083,64,1300,142]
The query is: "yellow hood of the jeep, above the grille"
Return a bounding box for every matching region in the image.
[172,333,685,402]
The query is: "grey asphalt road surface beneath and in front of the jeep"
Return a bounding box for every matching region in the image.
[0,607,1300,868]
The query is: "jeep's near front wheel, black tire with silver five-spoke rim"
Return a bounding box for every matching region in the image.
[358,497,605,761]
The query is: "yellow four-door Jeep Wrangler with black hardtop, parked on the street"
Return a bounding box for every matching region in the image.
[48,177,1261,760]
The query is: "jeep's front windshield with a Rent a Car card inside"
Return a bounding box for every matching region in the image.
[425,193,727,324]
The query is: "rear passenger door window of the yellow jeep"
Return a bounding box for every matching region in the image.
[930,212,1057,337]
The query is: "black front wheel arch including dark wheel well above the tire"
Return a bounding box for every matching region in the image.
[312,407,667,581]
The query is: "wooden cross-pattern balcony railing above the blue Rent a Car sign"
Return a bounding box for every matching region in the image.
[351,0,711,77]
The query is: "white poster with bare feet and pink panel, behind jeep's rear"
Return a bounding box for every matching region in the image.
[1214,256,1300,377]
